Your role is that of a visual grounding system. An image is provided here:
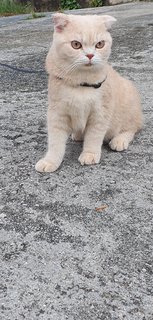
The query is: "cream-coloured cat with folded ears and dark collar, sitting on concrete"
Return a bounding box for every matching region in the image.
[36,13,142,172]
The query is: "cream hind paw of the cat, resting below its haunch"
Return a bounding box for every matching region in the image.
[109,131,134,151]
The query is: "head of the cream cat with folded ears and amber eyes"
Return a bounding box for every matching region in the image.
[46,13,116,78]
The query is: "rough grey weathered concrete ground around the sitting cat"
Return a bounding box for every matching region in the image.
[0,2,153,320]
